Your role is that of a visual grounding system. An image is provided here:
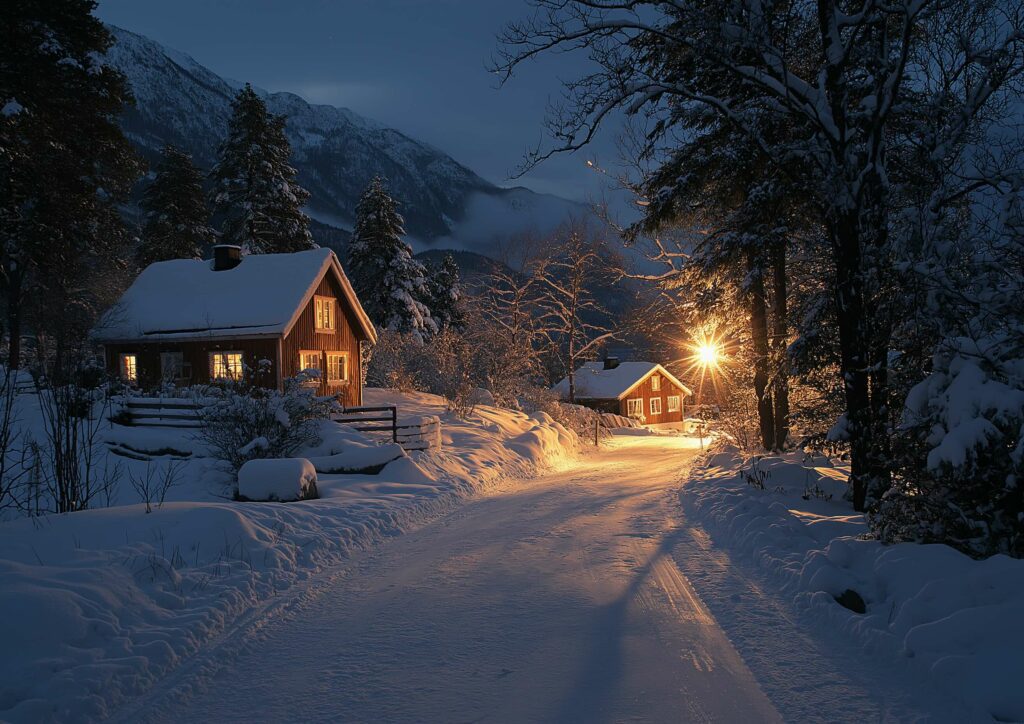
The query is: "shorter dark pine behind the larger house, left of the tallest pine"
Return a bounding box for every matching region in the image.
[138,145,215,266]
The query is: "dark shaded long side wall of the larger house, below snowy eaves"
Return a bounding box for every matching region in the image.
[104,338,278,389]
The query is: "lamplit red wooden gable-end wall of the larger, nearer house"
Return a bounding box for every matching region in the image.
[281,273,362,406]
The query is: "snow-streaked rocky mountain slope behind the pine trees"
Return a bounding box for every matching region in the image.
[106,26,587,254]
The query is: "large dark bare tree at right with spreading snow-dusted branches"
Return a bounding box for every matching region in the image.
[496,0,1024,510]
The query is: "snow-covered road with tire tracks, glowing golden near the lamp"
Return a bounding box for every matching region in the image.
[114,437,779,722]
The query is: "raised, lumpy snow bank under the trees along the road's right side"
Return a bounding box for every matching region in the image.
[681,448,1024,721]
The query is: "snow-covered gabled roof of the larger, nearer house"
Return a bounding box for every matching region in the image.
[94,249,377,342]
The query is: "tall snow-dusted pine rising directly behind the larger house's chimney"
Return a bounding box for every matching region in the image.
[211,83,316,254]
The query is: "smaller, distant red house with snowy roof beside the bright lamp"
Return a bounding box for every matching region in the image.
[552,357,693,427]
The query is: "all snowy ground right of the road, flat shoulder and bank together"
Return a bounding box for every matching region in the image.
[682,449,1024,722]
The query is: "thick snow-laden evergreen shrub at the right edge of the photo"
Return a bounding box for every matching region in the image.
[871,334,1024,557]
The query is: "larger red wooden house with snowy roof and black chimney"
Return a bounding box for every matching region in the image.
[94,246,377,404]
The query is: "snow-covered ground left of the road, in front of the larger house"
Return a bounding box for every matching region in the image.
[0,390,577,722]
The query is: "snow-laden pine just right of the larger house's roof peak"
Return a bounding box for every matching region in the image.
[348,176,438,342]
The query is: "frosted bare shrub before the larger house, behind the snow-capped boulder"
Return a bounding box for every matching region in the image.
[192,376,339,479]
